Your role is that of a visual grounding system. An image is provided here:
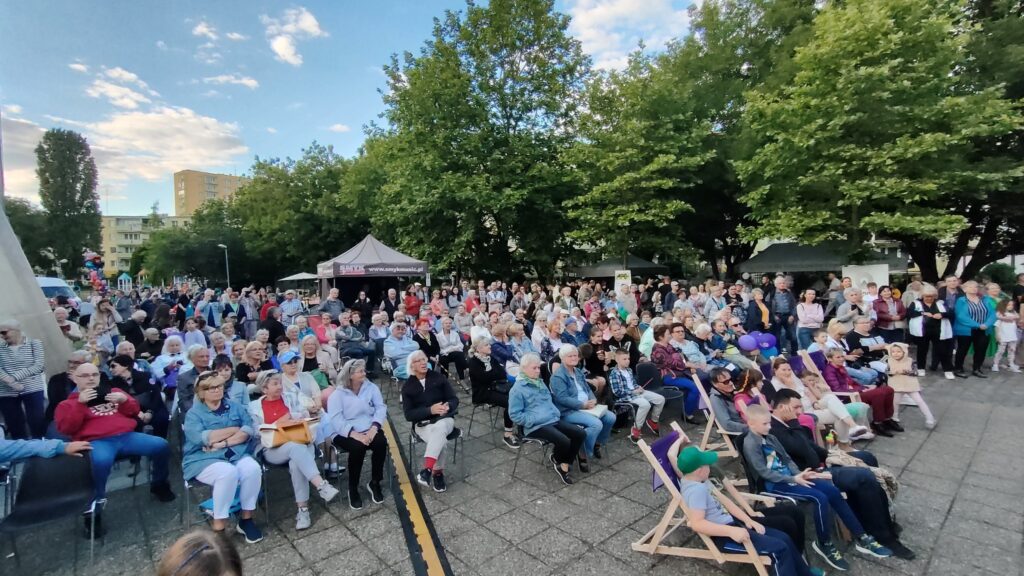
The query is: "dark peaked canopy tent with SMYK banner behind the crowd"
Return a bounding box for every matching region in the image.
[316,234,430,302]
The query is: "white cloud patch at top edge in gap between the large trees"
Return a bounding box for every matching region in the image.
[566,0,701,69]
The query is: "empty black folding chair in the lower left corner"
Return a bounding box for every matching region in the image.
[0,454,96,564]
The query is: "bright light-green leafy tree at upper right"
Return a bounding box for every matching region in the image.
[738,0,1021,278]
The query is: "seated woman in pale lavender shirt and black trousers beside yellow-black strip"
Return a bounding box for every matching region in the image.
[322,360,388,510]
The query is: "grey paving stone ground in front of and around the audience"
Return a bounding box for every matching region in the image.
[0,364,1024,576]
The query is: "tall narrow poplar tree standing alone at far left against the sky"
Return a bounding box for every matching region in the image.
[36,128,100,276]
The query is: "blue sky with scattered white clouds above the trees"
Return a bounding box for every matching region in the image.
[0,0,692,214]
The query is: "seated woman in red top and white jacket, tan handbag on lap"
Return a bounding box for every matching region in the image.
[249,364,338,530]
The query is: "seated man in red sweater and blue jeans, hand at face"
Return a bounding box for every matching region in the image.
[54,364,174,530]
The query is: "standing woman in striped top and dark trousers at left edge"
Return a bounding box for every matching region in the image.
[0,319,46,440]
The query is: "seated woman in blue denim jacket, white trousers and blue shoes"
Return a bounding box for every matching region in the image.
[181,372,263,544]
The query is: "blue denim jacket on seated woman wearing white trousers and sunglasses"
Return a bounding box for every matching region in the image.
[181,400,256,480]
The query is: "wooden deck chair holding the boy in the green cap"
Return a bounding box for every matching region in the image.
[632,428,771,576]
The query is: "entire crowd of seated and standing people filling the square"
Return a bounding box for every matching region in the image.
[0,275,1024,573]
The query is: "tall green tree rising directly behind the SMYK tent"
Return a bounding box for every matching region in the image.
[373,0,589,276]
